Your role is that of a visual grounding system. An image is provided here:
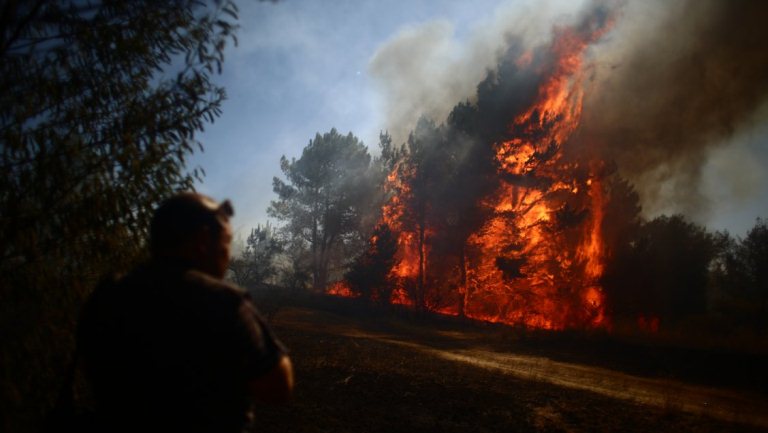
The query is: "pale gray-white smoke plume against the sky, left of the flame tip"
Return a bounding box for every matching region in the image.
[369,0,579,143]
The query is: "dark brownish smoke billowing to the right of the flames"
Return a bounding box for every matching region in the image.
[580,0,768,218]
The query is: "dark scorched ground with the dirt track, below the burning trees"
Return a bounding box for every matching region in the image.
[249,299,768,432]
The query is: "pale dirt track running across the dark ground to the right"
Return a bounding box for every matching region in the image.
[279,309,768,428]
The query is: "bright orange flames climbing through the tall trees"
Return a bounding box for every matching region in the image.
[332,10,610,329]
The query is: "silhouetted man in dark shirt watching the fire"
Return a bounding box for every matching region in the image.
[78,193,293,433]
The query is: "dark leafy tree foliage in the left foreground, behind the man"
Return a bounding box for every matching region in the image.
[0,0,237,431]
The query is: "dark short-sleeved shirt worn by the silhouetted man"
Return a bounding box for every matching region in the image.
[78,263,285,432]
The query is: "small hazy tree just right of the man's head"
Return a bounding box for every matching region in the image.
[229,224,283,288]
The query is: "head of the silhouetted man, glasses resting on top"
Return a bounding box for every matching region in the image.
[149,192,234,278]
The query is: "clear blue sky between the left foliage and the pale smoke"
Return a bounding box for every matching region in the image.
[190,0,540,236]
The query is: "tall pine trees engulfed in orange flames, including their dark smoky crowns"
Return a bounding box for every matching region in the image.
[336,4,624,328]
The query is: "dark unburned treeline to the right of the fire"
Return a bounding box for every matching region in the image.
[603,215,768,335]
